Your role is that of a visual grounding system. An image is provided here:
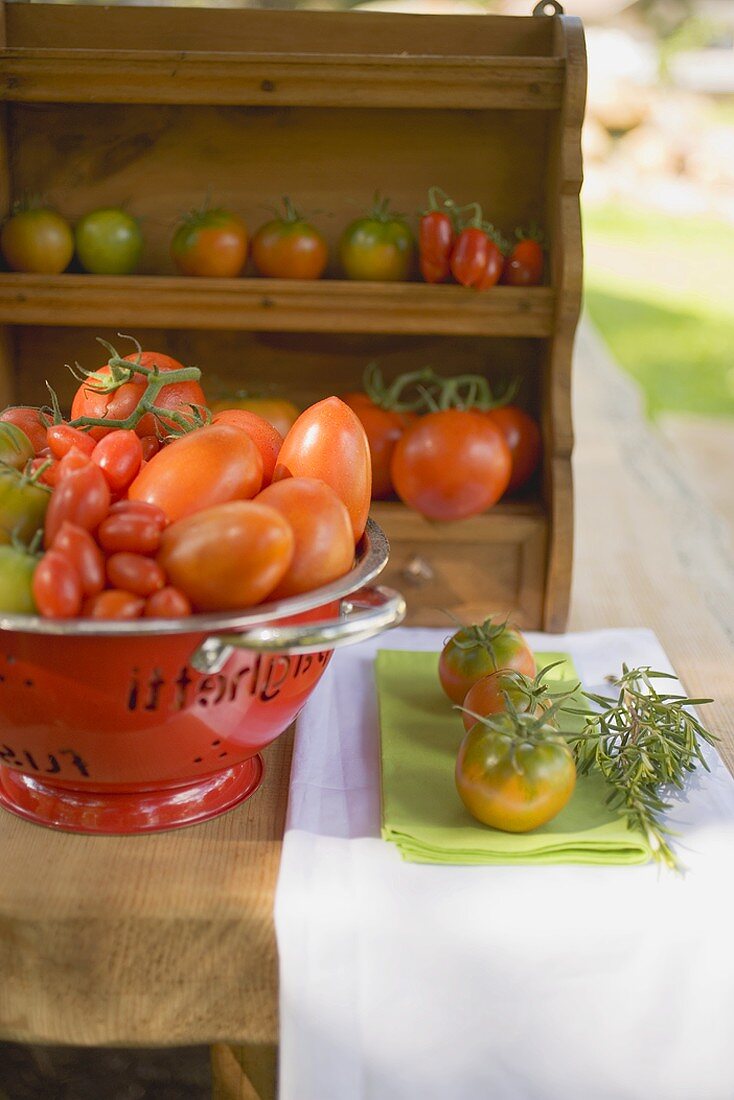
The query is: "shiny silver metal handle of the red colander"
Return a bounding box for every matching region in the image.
[189,584,405,673]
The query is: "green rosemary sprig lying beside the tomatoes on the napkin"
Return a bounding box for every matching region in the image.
[568,664,717,870]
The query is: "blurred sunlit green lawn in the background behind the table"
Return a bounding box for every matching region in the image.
[584,205,734,417]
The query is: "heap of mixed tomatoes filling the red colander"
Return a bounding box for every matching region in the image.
[0,336,371,619]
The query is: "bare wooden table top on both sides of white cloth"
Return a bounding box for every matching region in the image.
[0,329,734,1046]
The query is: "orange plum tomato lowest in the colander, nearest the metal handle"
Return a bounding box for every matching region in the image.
[157,501,295,612]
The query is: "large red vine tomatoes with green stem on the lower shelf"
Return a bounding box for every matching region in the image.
[343,366,541,520]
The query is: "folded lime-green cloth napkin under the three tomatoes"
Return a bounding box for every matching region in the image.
[375,649,650,864]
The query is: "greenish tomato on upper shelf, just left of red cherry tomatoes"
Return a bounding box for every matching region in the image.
[339,199,415,282]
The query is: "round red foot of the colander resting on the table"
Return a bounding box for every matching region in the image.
[0,756,264,836]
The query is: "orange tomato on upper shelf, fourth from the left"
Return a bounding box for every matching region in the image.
[252,198,329,278]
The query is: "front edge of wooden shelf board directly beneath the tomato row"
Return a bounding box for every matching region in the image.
[0,274,555,337]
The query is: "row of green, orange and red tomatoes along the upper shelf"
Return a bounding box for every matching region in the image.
[0,188,543,289]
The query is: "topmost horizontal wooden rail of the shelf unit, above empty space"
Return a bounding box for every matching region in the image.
[0,47,565,110]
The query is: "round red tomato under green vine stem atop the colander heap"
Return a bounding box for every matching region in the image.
[72,351,207,439]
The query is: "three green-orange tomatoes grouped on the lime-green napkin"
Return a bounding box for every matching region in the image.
[438,619,577,833]
